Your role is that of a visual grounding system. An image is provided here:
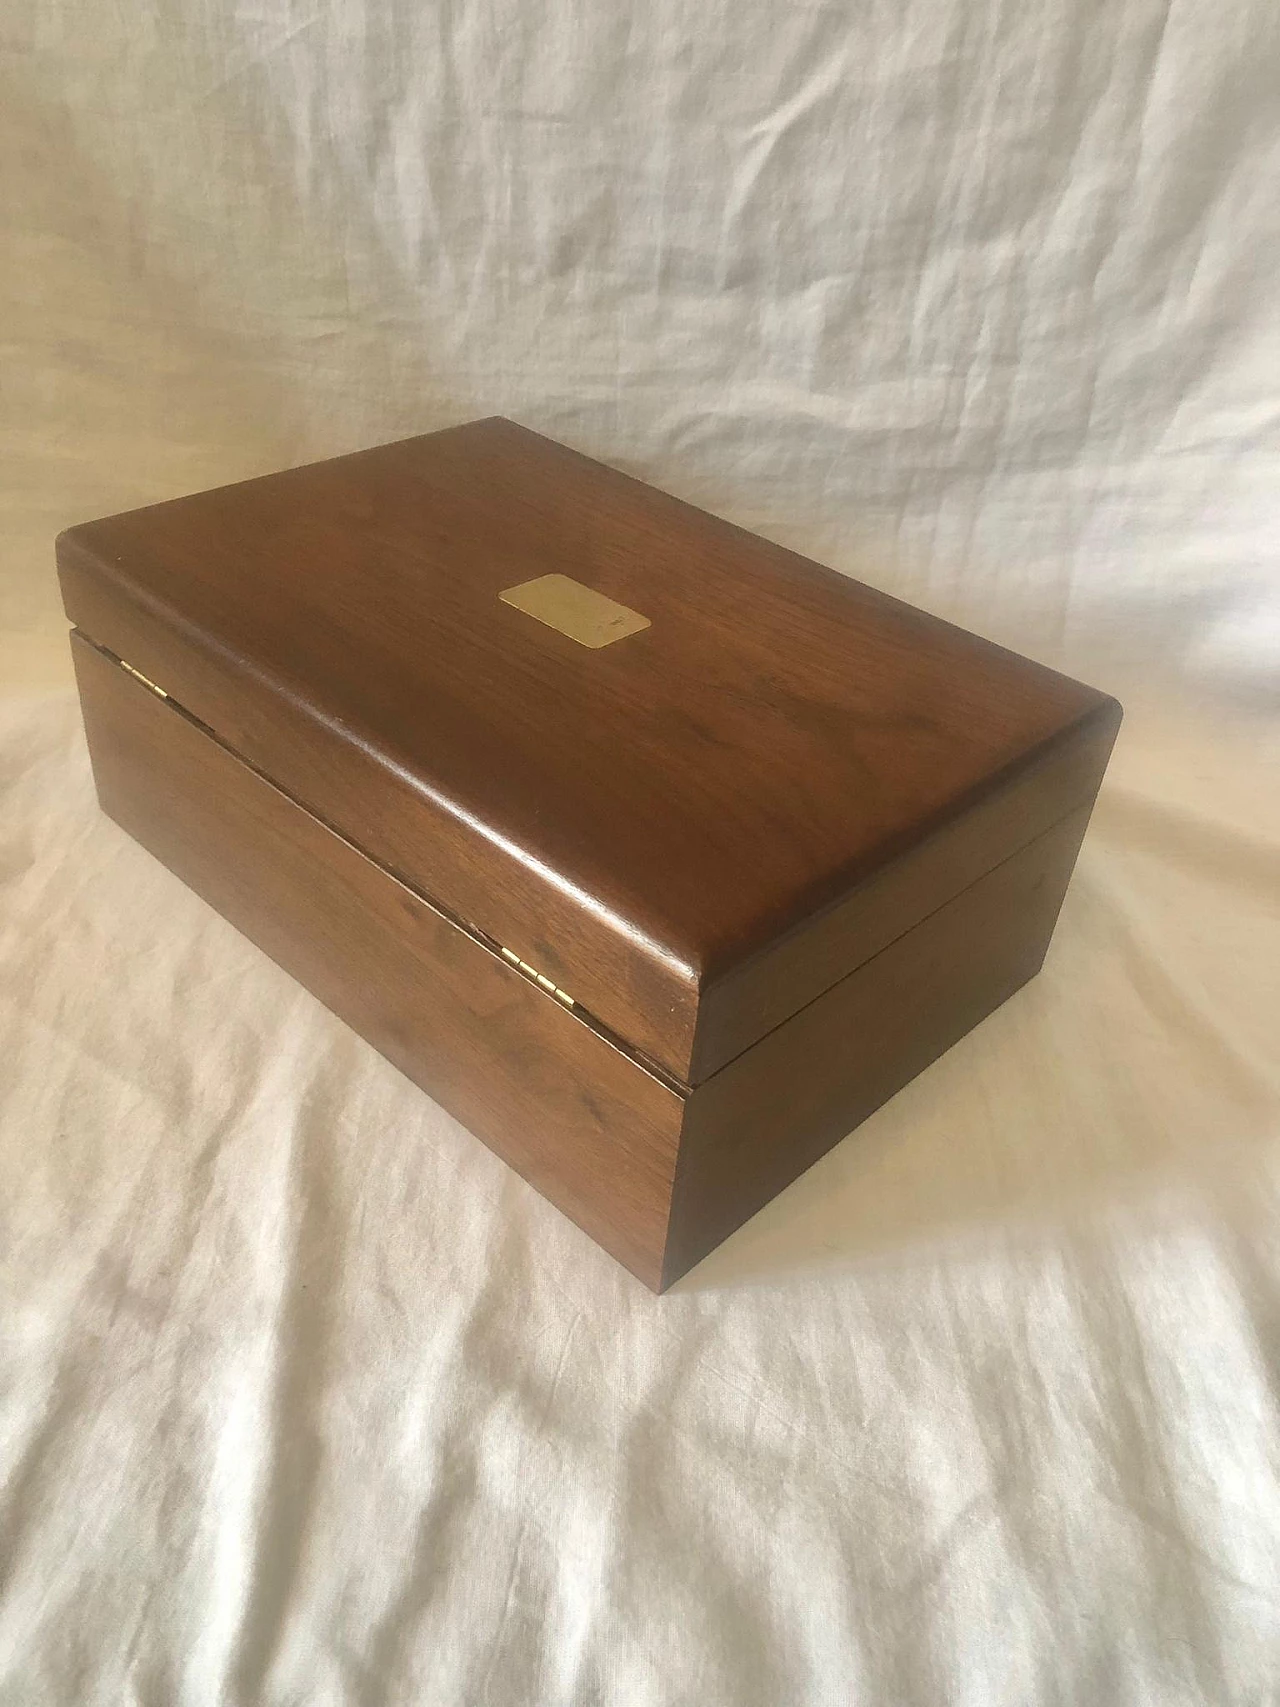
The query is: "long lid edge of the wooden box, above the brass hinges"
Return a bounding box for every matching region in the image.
[58,546,698,1079]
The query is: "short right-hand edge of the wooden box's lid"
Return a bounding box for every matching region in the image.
[689,700,1121,1084]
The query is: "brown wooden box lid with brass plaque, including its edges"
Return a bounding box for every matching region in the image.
[58,418,1120,1084]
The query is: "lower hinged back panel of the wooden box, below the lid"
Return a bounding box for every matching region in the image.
[72,635,683,1287]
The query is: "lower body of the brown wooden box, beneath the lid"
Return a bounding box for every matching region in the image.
[72,635,1112,1290]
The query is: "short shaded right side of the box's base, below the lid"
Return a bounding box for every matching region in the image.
[664,802,1092,1285]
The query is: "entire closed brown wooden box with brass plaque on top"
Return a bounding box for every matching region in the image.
[58,420,1120,1289]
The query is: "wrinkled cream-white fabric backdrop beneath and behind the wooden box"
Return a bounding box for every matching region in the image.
[0,0,1280,1707]
